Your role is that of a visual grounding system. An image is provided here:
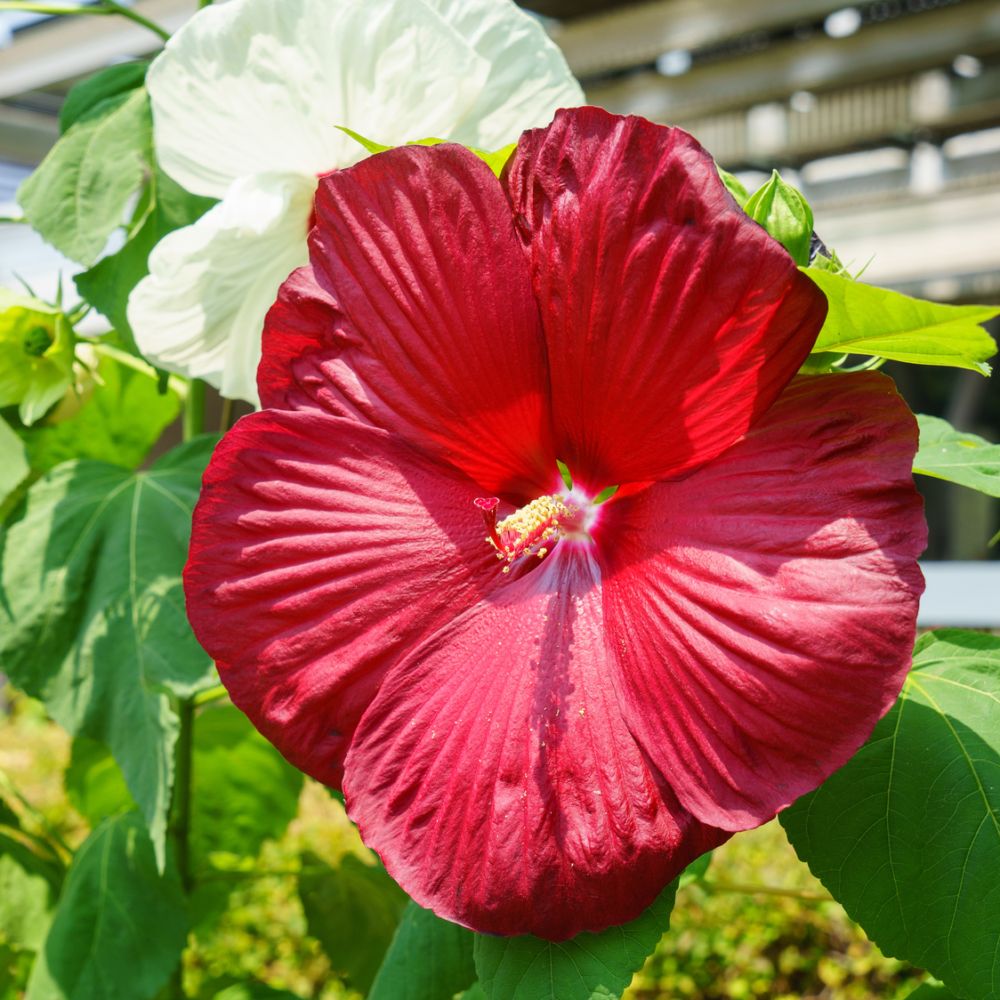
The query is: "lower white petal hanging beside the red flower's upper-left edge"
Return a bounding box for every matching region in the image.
[128,174,315,403]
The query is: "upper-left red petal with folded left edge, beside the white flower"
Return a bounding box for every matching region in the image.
[270,145,557,497]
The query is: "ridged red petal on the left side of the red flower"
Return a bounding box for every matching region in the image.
[185,410,498,784]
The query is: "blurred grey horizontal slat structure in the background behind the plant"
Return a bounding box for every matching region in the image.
[0,0,1000,584]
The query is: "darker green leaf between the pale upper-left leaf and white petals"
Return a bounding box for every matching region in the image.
[73,167,216,353]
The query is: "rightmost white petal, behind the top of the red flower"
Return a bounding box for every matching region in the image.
[423,0,584,149]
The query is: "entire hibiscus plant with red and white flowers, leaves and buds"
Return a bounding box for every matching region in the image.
[0,0,1000,1000]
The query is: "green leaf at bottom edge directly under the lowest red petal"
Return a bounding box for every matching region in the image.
[475,881,677,1000]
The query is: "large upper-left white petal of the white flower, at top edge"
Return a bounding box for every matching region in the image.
[147,0,490,197]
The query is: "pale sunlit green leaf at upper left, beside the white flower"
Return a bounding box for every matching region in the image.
[17,89,152,265]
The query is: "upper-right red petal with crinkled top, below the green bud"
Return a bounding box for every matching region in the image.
[507,108,826,489]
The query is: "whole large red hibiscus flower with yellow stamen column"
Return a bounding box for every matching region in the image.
[186,108,925,939]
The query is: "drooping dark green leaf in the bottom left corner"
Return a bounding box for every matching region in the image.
[27,814,187,1000]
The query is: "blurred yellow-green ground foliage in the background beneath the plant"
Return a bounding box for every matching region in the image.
[0,689,926,1000]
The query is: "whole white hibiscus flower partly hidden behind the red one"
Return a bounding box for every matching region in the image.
[128,0,583,402]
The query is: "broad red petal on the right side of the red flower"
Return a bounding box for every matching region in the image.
[599,374,926,830]
